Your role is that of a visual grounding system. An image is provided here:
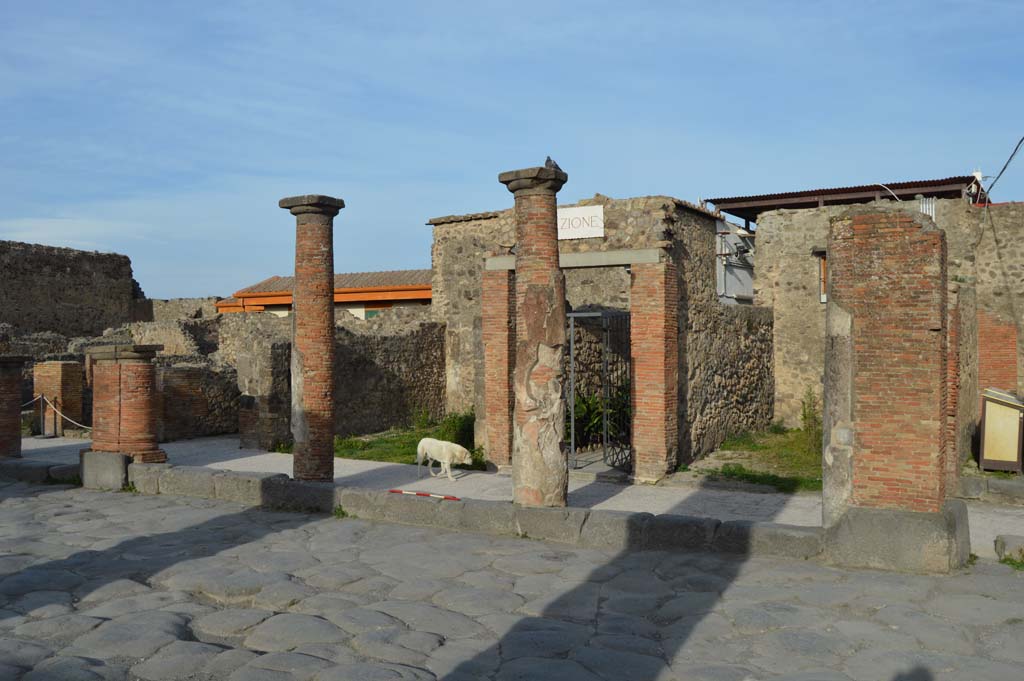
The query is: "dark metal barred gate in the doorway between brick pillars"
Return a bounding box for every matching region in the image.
[564,310,633,470]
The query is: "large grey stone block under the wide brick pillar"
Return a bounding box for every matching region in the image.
[824,499,971,572]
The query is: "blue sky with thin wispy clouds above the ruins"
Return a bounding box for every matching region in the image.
[0,0,1024,298]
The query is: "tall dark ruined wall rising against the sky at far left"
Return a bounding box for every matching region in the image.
[0,242,138,336]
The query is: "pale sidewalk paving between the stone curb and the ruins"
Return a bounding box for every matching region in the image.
[22,435,1024,558]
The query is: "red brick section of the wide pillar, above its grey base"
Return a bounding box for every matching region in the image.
[829,209,948,512]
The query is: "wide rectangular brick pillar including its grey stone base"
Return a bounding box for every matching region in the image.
[822,209,970,571]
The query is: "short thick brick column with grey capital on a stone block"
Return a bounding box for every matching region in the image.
[86,345,167,464]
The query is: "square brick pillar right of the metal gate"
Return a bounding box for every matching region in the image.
[630,262,679,482]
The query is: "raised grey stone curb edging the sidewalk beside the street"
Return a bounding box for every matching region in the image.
[0,460,823,559]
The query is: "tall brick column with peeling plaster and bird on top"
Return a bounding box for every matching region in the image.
[498,163,568,506]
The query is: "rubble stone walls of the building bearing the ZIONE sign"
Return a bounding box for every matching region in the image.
[431,195,774,459]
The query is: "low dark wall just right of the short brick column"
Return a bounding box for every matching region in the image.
[157,358,240,442]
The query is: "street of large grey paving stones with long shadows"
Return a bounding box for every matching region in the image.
[0,483,1024,681]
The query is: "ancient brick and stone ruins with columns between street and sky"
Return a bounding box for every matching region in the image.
[0,163,1024,571]
